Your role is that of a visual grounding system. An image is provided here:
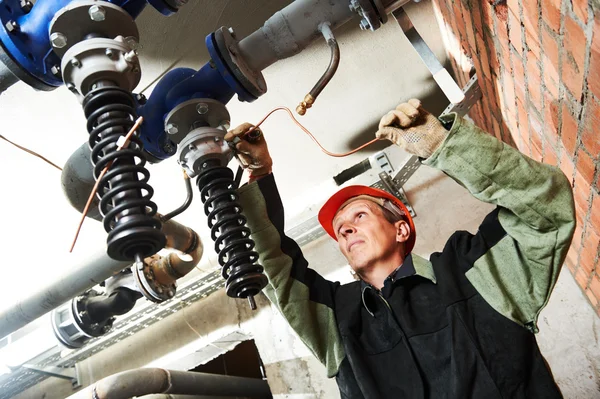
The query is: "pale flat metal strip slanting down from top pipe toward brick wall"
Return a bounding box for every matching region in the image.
[392,8,465,104]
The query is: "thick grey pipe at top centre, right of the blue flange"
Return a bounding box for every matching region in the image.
[239,0,355,72]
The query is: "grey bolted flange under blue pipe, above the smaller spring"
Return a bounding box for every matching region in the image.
[165,98,230,144]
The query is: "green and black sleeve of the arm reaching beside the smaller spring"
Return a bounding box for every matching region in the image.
[238,174,345,377]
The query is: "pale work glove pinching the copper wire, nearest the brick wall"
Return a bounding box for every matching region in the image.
[375,99,448,158]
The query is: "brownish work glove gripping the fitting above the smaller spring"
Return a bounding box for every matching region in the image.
[225,123,273,180]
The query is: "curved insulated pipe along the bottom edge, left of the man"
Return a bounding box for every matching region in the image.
[69,368,272,399]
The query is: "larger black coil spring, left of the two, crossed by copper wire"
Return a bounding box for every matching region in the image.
[83,86,165,260]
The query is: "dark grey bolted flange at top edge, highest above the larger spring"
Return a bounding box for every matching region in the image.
[50,0,140,57]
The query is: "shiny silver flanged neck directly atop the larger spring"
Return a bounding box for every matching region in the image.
[61,36,142,101]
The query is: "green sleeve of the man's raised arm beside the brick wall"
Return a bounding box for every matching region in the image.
[424,114,575,332]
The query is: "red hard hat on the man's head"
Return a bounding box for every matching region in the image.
[319,186,417,254]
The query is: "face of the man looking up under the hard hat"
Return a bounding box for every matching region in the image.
[333,199,410,274]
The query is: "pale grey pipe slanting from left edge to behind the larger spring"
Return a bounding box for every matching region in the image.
[0,250,128,337]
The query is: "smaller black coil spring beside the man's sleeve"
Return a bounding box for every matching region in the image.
[197,165,267,298]
